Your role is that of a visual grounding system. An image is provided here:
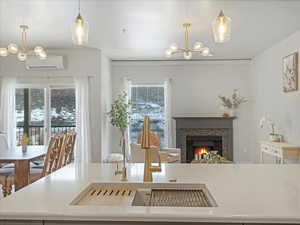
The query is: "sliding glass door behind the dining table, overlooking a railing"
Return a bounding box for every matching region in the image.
[16,87,76,145]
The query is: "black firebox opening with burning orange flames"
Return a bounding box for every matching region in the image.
[186,136,223,163]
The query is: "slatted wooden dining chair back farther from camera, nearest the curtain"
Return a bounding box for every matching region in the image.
[58,131,76,168]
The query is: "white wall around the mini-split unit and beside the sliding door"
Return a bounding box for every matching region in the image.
[0,48,107,162]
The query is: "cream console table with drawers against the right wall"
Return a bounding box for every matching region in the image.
[260,141,300,164]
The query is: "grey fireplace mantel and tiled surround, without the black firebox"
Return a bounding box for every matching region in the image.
[173,115,235,163]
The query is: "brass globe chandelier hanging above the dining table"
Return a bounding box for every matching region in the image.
[0,25,47,62]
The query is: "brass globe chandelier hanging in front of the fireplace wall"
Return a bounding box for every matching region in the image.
[166,23,212,60]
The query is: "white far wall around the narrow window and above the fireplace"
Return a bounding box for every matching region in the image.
[111,61,251,162]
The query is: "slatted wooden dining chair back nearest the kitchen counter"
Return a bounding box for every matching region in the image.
[42,133,64,176]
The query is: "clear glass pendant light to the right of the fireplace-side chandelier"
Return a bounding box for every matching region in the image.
[212,10,231,43]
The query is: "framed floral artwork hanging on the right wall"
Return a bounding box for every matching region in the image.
[282,52,298,92]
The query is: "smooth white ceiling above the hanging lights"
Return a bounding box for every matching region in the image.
[0,0,300,59]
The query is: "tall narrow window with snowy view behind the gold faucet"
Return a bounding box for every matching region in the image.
[130,85,167,147]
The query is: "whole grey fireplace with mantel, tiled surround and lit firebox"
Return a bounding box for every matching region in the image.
[174,117,234,163]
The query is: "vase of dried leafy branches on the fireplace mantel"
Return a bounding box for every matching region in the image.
[218,89,248,117]
